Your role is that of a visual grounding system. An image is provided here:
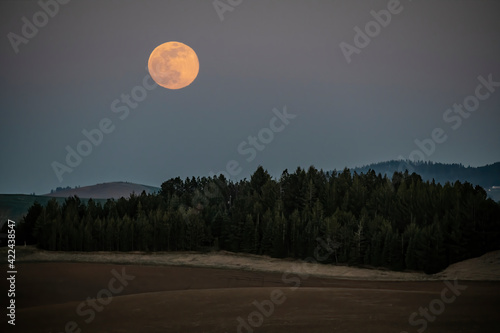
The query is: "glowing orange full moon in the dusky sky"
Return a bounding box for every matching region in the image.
[148,42,200,89]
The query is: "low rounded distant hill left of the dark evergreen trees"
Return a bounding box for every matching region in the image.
[45,182,160,199]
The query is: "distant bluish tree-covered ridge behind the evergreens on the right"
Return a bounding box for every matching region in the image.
[350,160,500,201]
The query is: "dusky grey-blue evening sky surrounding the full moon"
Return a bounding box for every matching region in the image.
[0,0,500,194]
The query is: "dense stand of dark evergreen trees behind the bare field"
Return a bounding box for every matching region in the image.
[15,167,500,273]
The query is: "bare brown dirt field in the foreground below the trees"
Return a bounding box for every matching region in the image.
[0,262,500,333]
